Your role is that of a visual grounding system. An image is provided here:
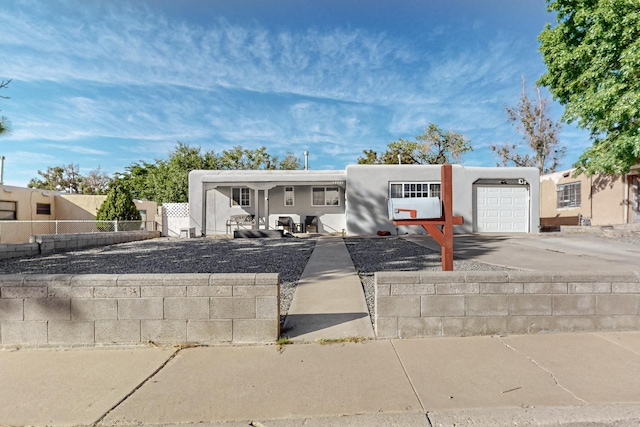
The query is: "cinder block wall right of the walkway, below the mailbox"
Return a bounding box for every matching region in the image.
[375,271,640,338]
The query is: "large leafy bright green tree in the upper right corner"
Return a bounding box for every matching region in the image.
[538,0,640,175]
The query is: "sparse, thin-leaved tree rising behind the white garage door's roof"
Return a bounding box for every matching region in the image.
[490,76,566,173]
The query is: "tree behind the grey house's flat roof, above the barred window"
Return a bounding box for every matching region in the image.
[358,123,473,165]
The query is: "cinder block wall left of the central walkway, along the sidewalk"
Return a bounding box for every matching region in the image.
[0,274,280,347]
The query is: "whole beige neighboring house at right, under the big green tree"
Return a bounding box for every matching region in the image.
[540,165,640,229]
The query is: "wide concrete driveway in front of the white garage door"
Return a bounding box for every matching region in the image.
[405,233,640,273]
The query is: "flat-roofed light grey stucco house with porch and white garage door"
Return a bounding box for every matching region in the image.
[189,165,539,235]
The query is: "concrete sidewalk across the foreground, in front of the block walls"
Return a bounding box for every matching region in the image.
[0,332,640,427]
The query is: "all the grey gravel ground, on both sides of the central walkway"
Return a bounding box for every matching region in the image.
[0,233,640,326]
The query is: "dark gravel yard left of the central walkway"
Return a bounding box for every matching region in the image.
[0,238,316,313]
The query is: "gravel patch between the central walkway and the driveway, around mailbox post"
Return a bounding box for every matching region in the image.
[344,237,510,321]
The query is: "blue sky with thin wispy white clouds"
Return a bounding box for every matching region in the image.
[0,0,589,186]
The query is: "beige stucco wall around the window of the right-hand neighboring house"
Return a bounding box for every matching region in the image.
[540,169,628,225]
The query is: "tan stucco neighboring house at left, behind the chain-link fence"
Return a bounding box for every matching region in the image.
[0,185,157,243]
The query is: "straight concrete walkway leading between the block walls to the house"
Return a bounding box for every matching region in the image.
[283,236,374,341]
